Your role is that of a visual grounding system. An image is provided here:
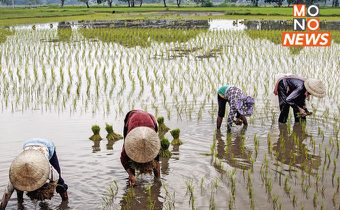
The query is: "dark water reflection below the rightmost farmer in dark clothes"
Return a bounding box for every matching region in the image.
[273,123,321,174]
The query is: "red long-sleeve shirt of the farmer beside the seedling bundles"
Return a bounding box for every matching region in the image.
[120,110,159,170]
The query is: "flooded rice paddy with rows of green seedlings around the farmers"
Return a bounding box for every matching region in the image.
[0,22,340,209]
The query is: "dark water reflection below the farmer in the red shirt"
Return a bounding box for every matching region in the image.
[120,179,163,210]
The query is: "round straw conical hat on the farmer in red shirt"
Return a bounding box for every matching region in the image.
[124,127,161,163]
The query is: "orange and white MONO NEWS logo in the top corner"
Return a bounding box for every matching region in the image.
[282,4,331,47]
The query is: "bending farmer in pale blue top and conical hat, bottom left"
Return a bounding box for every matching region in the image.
[0,138,68,209]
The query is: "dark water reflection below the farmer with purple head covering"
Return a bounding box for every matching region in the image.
[216,129,252,170]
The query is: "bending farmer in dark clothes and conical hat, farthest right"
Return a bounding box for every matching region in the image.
[274,76,326,123]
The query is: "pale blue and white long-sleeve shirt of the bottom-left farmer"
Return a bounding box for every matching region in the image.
[0,138,59,210]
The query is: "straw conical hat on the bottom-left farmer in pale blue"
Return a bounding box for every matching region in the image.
[9,149,50,191]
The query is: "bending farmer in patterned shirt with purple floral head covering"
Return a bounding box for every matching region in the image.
[217,85,254,131]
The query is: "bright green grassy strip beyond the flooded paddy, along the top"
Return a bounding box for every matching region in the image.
[0,5,340,26]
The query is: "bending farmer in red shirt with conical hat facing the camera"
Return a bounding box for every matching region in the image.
[120,110,160,185]
